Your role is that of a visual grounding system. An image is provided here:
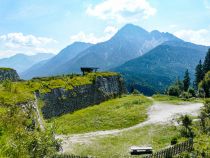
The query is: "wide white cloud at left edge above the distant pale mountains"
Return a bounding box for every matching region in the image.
[0,32,57,56]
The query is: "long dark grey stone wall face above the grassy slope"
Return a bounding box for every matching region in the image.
[37,75,127,118]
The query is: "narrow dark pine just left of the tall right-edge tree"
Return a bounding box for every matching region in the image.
[195,60,204,88]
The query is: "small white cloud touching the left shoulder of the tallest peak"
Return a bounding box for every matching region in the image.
[70,26,117,44]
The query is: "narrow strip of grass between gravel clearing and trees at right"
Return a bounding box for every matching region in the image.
[152,94,203,105]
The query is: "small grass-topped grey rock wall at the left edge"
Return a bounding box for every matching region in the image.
[0,68,20,81]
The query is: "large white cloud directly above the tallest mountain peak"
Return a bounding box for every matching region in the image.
[86,0,156,23]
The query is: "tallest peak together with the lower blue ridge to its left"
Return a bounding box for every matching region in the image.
[22,24,181,78]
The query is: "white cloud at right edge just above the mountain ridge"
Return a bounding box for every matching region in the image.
[174,29,210,46]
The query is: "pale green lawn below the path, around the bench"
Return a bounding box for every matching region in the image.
[69,125,179,158]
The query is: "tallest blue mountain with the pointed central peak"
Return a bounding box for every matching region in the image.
[57,24,181,73]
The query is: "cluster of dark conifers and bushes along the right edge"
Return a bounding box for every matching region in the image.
[166,49,210,98]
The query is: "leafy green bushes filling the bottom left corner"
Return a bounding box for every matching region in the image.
[0,105,60,158]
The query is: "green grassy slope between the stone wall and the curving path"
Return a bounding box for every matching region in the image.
[48,95,152,134]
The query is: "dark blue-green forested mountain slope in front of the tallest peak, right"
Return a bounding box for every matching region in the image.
[113,41,208,94]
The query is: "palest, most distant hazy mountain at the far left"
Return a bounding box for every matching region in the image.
[0,53,53,73]
